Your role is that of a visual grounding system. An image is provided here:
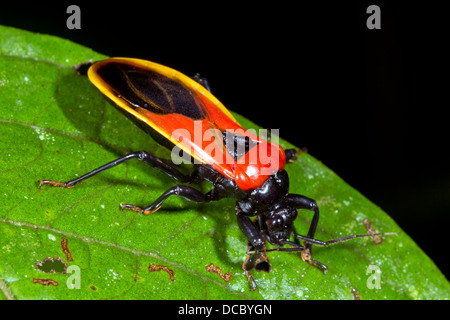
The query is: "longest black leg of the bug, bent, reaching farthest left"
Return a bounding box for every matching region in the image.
[39,151,191,188]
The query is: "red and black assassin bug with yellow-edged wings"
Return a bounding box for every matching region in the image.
[39,58,396,289]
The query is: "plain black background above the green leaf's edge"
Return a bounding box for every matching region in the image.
[0,0,450,278]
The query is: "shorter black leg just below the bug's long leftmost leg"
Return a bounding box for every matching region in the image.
[121,185,215,215]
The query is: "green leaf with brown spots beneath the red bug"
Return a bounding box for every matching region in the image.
[0,27,450,299]
